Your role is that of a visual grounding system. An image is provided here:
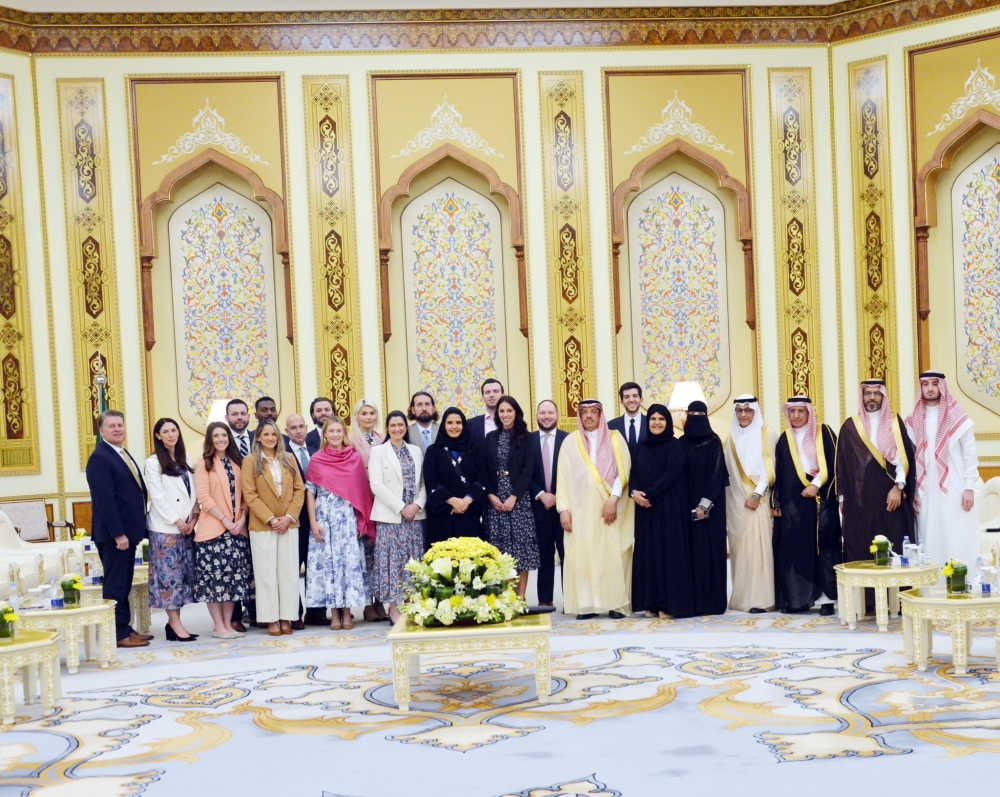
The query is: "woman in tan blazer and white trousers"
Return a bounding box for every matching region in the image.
[243,421,305,636]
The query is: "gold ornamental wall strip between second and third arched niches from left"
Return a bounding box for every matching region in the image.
[538,72,596,431]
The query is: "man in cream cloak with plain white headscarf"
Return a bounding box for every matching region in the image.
[725,394,776,614]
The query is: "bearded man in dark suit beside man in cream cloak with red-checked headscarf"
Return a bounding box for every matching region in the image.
[531,399,566,606]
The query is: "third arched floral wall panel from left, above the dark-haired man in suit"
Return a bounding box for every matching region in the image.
[637,185,725,403]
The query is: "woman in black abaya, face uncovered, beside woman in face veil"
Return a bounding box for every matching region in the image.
[629,404,695,618]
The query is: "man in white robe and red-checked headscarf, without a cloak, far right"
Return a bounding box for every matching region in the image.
[906,371,979,564]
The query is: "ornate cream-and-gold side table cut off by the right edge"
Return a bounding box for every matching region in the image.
[899,587,1000,676]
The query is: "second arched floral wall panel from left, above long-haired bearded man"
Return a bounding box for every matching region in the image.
[410,191,497,411]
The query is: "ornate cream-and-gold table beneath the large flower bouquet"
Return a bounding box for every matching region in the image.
[389,614,552,711]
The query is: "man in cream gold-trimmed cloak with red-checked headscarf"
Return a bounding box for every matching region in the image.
[556,399,635,620]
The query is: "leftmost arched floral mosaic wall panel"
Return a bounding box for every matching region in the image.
[181,197,270,418]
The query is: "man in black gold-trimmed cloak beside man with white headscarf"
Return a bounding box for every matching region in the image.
[771,396,842,616]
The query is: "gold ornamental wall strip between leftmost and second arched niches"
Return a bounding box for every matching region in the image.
[304,76,362,421]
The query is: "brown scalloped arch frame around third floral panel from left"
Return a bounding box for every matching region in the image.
[611,139,757,334]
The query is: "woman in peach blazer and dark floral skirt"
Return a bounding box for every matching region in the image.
[194,422,251,639]
